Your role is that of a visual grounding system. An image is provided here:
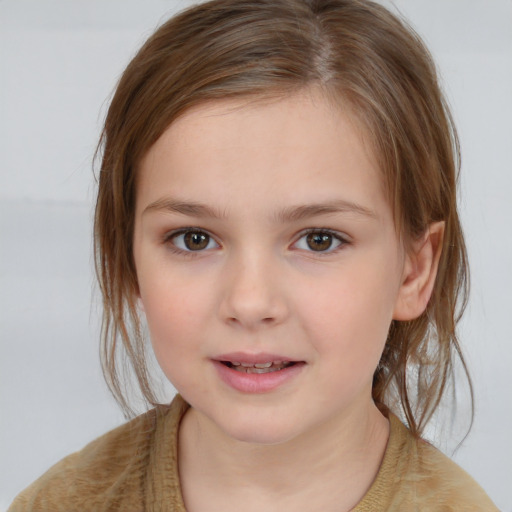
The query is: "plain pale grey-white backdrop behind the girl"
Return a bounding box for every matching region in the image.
[0,0,512,512]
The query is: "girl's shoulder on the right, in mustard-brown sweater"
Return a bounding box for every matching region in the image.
[390,418,498,512]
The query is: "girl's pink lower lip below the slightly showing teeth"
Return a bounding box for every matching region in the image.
[213,361,305,393]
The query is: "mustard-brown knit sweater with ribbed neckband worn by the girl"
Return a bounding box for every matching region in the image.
[8,395,498,512]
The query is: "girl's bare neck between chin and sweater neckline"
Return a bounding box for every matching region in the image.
[179,402,389,512]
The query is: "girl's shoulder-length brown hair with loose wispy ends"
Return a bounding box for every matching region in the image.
[95,0,472,435]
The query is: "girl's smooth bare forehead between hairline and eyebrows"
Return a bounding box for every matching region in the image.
[137,90,383,224]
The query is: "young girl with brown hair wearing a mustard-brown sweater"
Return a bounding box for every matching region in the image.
[11,0,497,512]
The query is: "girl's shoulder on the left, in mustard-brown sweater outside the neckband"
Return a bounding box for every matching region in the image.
[9,405,187,512]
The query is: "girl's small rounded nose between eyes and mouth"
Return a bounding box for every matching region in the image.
[220,253,288,330]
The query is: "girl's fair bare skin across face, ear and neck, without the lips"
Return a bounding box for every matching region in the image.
[134,89,443,511]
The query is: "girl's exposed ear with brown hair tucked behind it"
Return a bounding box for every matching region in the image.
[393,221,444,321]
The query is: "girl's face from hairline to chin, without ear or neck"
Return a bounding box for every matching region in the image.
[134,92,404,443]
